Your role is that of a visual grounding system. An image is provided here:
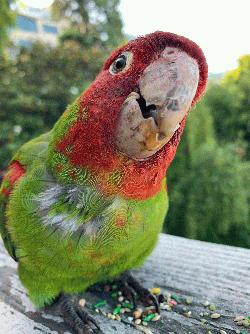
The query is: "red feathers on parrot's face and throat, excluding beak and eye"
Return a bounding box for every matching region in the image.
[55,32,208,199]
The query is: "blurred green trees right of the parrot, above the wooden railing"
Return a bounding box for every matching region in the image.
[165,55,250,248]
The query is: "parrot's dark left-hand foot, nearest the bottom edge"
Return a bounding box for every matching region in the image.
[58,294,102,334]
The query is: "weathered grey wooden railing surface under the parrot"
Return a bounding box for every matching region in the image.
[0,235,250,334]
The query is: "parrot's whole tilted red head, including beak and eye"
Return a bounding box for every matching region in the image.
[53,31,207,198]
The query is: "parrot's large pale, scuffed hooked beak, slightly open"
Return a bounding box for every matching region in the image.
[116,47,199,160]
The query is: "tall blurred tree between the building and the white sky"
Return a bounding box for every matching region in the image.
[52,0,124,49]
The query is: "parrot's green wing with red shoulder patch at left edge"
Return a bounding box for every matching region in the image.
[0,132,50,261]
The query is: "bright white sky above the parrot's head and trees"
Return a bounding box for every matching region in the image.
[22,0,250,73]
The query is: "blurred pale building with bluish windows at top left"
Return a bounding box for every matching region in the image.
[10,7,62,47]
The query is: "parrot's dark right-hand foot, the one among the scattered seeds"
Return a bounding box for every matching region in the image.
[117,272,160,314]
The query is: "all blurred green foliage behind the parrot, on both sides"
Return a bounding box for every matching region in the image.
[0,0,250,248]
